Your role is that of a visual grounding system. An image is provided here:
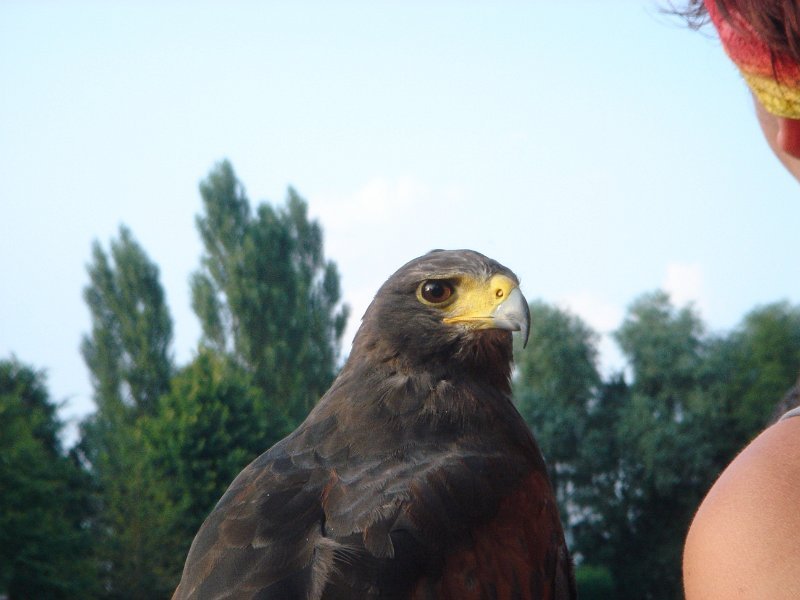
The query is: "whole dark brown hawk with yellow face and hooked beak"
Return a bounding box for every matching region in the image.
[173,250,576,600]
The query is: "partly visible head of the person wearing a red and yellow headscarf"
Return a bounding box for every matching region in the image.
[686,0,800,181]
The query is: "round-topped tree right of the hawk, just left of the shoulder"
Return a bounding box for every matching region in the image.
[607,292,713,599]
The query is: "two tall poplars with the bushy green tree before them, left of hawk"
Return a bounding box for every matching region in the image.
[71,162,347,599]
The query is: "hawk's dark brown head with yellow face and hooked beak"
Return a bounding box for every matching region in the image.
[353,250,530,380]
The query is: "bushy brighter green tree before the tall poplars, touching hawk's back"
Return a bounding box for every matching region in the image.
[142,350,287,568]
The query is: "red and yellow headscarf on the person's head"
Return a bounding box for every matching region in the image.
[705,0,800,119]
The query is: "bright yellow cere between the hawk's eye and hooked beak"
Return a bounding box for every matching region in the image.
[442,275,517,328]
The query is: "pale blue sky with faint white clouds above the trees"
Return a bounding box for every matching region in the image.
[0,0,800,440]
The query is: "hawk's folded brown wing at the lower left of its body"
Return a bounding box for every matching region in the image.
[173,443,324,599]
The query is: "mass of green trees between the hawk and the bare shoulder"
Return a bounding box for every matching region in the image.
[515,292,800,600]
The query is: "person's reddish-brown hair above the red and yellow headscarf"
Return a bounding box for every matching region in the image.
[675,0,800,63]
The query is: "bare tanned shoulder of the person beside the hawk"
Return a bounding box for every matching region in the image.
[683,417,800,600]
